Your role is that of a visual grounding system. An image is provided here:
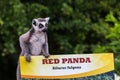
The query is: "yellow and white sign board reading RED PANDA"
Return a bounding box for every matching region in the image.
[20,53,114,79]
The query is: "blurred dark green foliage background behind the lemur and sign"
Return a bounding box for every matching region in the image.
[0,0,120,80]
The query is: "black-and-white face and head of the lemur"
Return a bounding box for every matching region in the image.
[32,17,49,32]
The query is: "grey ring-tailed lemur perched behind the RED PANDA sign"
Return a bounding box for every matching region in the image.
[16,17,50,80]
